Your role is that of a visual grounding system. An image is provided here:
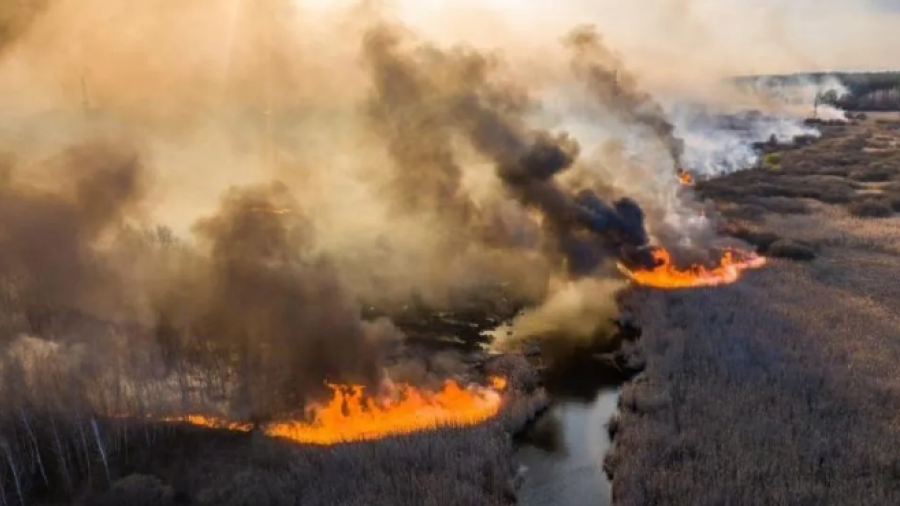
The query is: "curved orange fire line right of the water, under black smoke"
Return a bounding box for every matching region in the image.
[618,248,766,289]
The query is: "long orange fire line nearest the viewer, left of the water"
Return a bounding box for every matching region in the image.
[152,376,507,445]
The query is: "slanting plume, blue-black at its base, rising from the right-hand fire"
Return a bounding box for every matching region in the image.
[365,25,648,275]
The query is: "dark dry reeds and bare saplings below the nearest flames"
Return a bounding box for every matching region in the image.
[0,348,546,506]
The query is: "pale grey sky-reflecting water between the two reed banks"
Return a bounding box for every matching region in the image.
[517,388,618,506]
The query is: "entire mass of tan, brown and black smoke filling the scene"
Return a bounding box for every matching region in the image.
[0,0,884,428]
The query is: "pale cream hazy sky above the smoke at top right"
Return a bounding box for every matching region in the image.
[378,0,900,73]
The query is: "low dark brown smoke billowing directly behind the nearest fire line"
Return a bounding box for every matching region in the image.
[0,151,399,417]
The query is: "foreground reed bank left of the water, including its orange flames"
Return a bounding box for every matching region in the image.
[0,342,546,506]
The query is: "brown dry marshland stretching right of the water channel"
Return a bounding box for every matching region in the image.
[606,121,900,506]
